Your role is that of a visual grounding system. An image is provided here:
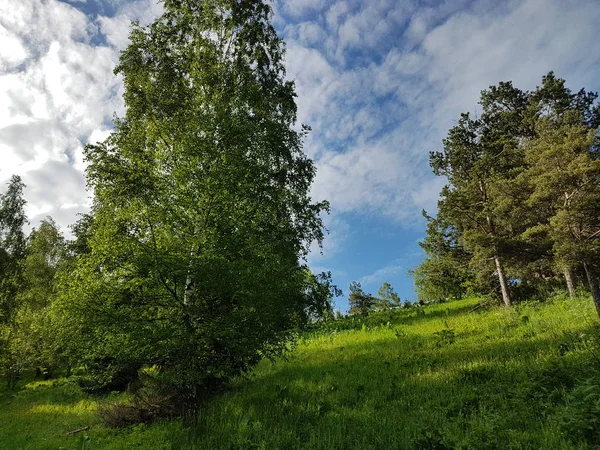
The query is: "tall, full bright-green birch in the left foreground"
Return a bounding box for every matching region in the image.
[61,0,327,412]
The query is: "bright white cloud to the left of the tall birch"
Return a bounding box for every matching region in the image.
[0,0,160,234]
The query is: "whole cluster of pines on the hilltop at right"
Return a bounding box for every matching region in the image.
[413,72,600,314]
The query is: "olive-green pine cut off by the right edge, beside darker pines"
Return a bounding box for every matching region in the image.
[526,114,600,314]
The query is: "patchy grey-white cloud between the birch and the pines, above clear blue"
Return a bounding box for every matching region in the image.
[286,0,600,239]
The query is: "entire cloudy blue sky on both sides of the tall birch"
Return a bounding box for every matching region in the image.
[0,0,600,311]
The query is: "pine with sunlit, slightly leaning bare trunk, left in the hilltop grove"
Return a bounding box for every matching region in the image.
[431,113,518,306]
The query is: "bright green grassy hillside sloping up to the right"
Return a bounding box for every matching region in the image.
[0,298,600,450]
